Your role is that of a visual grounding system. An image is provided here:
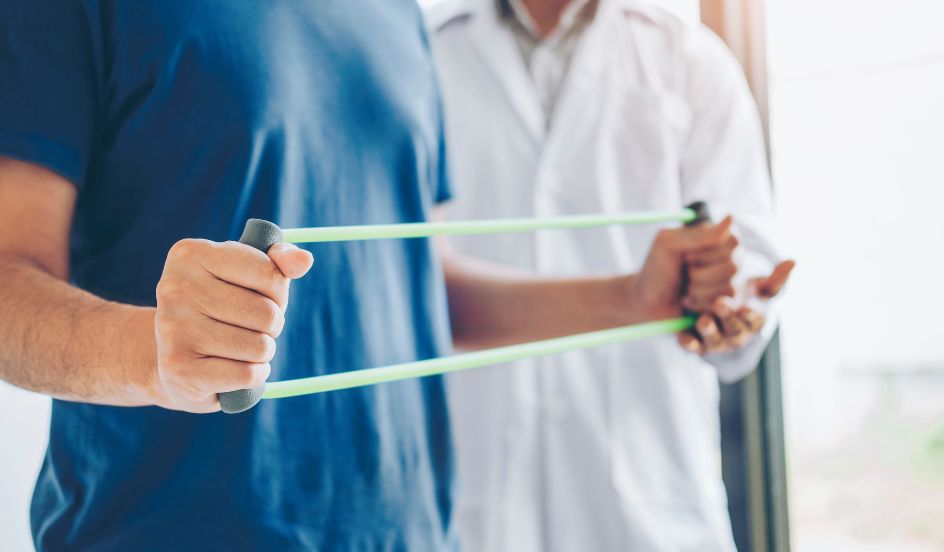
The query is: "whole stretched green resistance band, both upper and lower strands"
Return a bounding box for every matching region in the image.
[219,202,709,414]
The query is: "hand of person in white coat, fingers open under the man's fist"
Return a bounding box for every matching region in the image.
[678,261,796,354]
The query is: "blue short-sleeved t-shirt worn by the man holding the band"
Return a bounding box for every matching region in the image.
[0,0,454,551]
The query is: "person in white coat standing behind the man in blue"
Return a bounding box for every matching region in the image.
[427,0,793,552]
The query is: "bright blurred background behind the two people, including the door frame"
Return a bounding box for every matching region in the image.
[0,0,944,552]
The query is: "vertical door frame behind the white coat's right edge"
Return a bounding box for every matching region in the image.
[700,0,790,552]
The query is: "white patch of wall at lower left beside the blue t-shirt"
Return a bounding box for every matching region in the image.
[0,383,50,552]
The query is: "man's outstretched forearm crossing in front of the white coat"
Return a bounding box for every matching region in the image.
[443,253,652,349]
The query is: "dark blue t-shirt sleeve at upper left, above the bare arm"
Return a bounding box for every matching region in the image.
[0,0,101,187]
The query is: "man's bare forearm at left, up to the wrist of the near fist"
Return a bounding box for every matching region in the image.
[0,257,157,406]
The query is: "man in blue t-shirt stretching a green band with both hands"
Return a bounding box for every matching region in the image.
[0,0,733,551]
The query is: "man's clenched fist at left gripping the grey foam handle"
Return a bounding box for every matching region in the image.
[154,240,312,412]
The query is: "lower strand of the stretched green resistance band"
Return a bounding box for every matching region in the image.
[262,317,695,399]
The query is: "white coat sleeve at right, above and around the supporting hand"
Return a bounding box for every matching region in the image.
[681,27,781,382]
